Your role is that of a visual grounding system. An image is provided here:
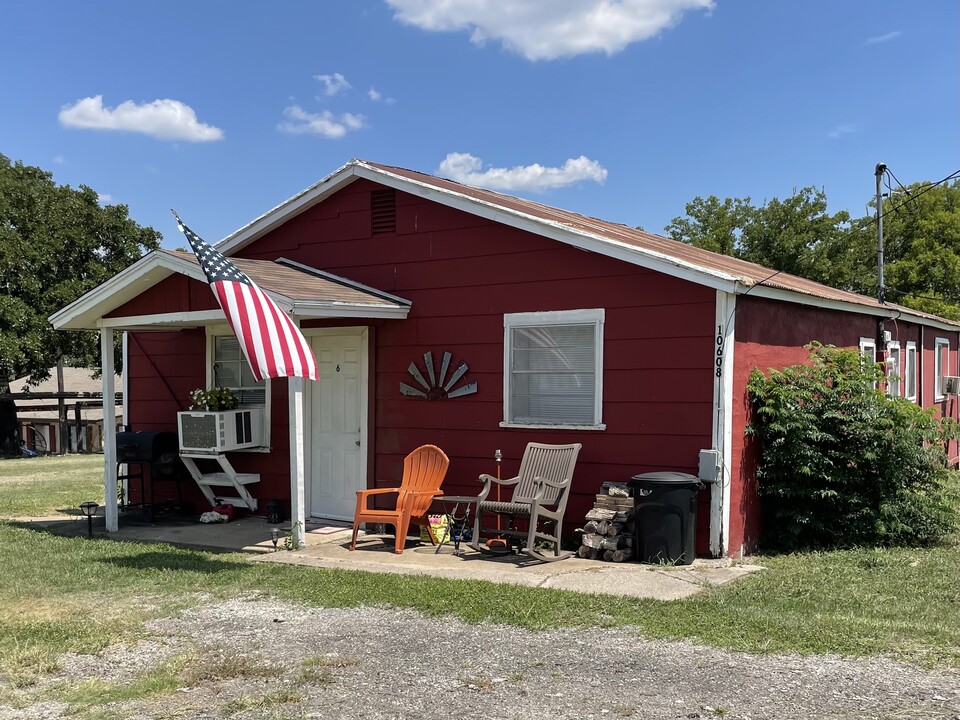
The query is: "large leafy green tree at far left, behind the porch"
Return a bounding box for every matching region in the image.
[0,155,160,454]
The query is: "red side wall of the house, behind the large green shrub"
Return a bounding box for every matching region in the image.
[729,296,957,555]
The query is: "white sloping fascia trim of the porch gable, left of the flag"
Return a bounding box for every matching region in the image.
[48,250,206,330]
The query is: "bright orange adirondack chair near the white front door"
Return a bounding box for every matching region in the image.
[350,445,450,555]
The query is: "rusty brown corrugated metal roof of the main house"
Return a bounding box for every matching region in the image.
[356,161,960,326]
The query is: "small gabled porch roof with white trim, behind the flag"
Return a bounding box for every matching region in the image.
[50,250,411,331]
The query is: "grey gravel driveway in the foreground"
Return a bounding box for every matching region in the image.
[0,598,960,720]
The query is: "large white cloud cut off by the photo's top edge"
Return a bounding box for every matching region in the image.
[386,0,714,60]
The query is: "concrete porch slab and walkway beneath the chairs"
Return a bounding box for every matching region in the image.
[20,515,761,600]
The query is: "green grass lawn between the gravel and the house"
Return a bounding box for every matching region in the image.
[0,458,960,683]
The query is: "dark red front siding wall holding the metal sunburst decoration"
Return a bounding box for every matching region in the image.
[121,181,715,552]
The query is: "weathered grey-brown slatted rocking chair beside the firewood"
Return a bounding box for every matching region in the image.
[470,443,582,562]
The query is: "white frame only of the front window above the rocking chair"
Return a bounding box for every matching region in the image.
[500,308,607,430]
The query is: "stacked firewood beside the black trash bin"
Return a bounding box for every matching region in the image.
[577,483,636,562]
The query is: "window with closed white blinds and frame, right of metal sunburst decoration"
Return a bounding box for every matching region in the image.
[504,309,603,427]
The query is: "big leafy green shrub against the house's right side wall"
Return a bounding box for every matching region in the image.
[747,343,960,551]
